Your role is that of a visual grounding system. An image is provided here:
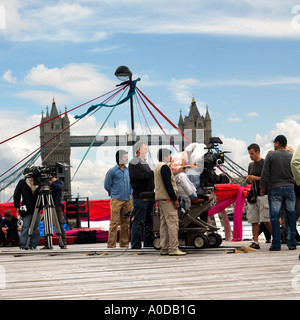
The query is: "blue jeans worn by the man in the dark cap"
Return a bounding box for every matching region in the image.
[268,186,297,249]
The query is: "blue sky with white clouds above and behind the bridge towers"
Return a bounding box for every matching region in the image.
[0,0,300,201]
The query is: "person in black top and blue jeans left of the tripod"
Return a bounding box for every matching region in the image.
[13,175,40,250]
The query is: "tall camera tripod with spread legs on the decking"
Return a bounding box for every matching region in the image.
[25,186,64,249]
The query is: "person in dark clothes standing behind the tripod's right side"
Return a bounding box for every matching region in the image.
[43,175,67,249]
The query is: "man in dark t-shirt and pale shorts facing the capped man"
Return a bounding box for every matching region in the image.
[246,143,272,249]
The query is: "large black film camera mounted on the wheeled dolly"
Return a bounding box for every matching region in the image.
[200,137,229,187]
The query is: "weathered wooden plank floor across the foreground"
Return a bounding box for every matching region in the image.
[0,241,300,300]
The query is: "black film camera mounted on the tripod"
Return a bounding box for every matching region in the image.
[23,162,68,190]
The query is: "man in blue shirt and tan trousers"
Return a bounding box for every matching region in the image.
[104,150,133,248]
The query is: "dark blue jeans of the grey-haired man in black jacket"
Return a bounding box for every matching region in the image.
[131,199,154,249]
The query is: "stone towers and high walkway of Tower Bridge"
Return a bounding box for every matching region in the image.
[40,98,212,196]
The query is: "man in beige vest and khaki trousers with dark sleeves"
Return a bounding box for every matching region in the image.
[154,148,186,256]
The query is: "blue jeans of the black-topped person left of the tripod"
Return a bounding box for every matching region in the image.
[19,213,41,248]
